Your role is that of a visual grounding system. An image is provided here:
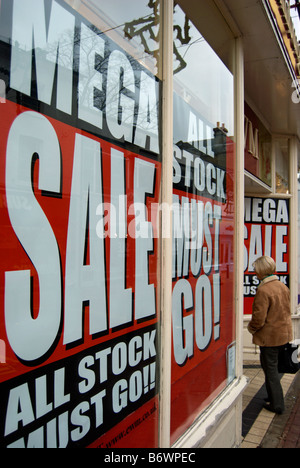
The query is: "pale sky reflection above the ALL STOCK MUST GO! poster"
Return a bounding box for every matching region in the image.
[174,6,234,136]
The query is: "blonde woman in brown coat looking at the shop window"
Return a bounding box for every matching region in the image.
[248,256,293,414]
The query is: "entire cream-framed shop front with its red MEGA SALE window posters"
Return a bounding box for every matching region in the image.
[0,0,298,449]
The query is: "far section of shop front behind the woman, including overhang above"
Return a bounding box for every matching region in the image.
[239,0,300,359]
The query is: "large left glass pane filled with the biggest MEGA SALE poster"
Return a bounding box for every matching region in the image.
[0,0,161,448]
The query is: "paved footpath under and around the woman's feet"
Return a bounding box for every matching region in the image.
[240,360,300,448]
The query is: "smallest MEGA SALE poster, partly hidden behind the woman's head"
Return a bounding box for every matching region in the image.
[244,198,289,314]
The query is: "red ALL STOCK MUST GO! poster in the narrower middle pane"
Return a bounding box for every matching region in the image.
[171,96,235,441]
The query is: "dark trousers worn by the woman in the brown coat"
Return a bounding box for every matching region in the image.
[260,346,284,411]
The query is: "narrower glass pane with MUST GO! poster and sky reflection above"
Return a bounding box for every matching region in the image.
[171,2,235,442]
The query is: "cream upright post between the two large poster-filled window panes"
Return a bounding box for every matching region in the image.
[159,0,173,448]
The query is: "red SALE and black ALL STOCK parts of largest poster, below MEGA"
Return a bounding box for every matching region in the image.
[0,102,160,446]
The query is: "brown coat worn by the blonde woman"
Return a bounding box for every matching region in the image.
[248,276,293,347]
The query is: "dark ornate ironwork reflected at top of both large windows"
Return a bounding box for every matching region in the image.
[124,0,192,74]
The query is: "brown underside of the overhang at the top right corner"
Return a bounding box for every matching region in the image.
[223,0,300,138]
